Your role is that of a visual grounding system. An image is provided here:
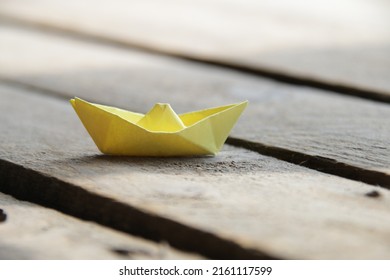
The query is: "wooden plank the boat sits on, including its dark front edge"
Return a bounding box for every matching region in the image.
[0,86,390,259]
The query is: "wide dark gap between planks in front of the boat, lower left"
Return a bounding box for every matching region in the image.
[0,159,278,260]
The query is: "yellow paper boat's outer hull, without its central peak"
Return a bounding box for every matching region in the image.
[71,98,247,157]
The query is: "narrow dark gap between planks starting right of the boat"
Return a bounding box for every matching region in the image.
[226,137,390,189]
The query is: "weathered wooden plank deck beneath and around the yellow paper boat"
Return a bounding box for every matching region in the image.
[0,0,390,259]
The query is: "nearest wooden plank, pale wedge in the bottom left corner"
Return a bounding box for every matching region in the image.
[0,193,200,259]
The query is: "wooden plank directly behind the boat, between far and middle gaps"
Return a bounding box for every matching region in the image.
[0,27,390,187]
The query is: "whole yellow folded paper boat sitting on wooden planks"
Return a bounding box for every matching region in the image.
[70,98,248,156]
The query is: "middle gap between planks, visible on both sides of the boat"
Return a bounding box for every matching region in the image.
[0,77,390,190]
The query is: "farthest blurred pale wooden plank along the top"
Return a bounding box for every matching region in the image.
[0,0,390,101]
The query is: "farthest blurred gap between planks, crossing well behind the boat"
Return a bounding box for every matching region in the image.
[0,13,390,104]
